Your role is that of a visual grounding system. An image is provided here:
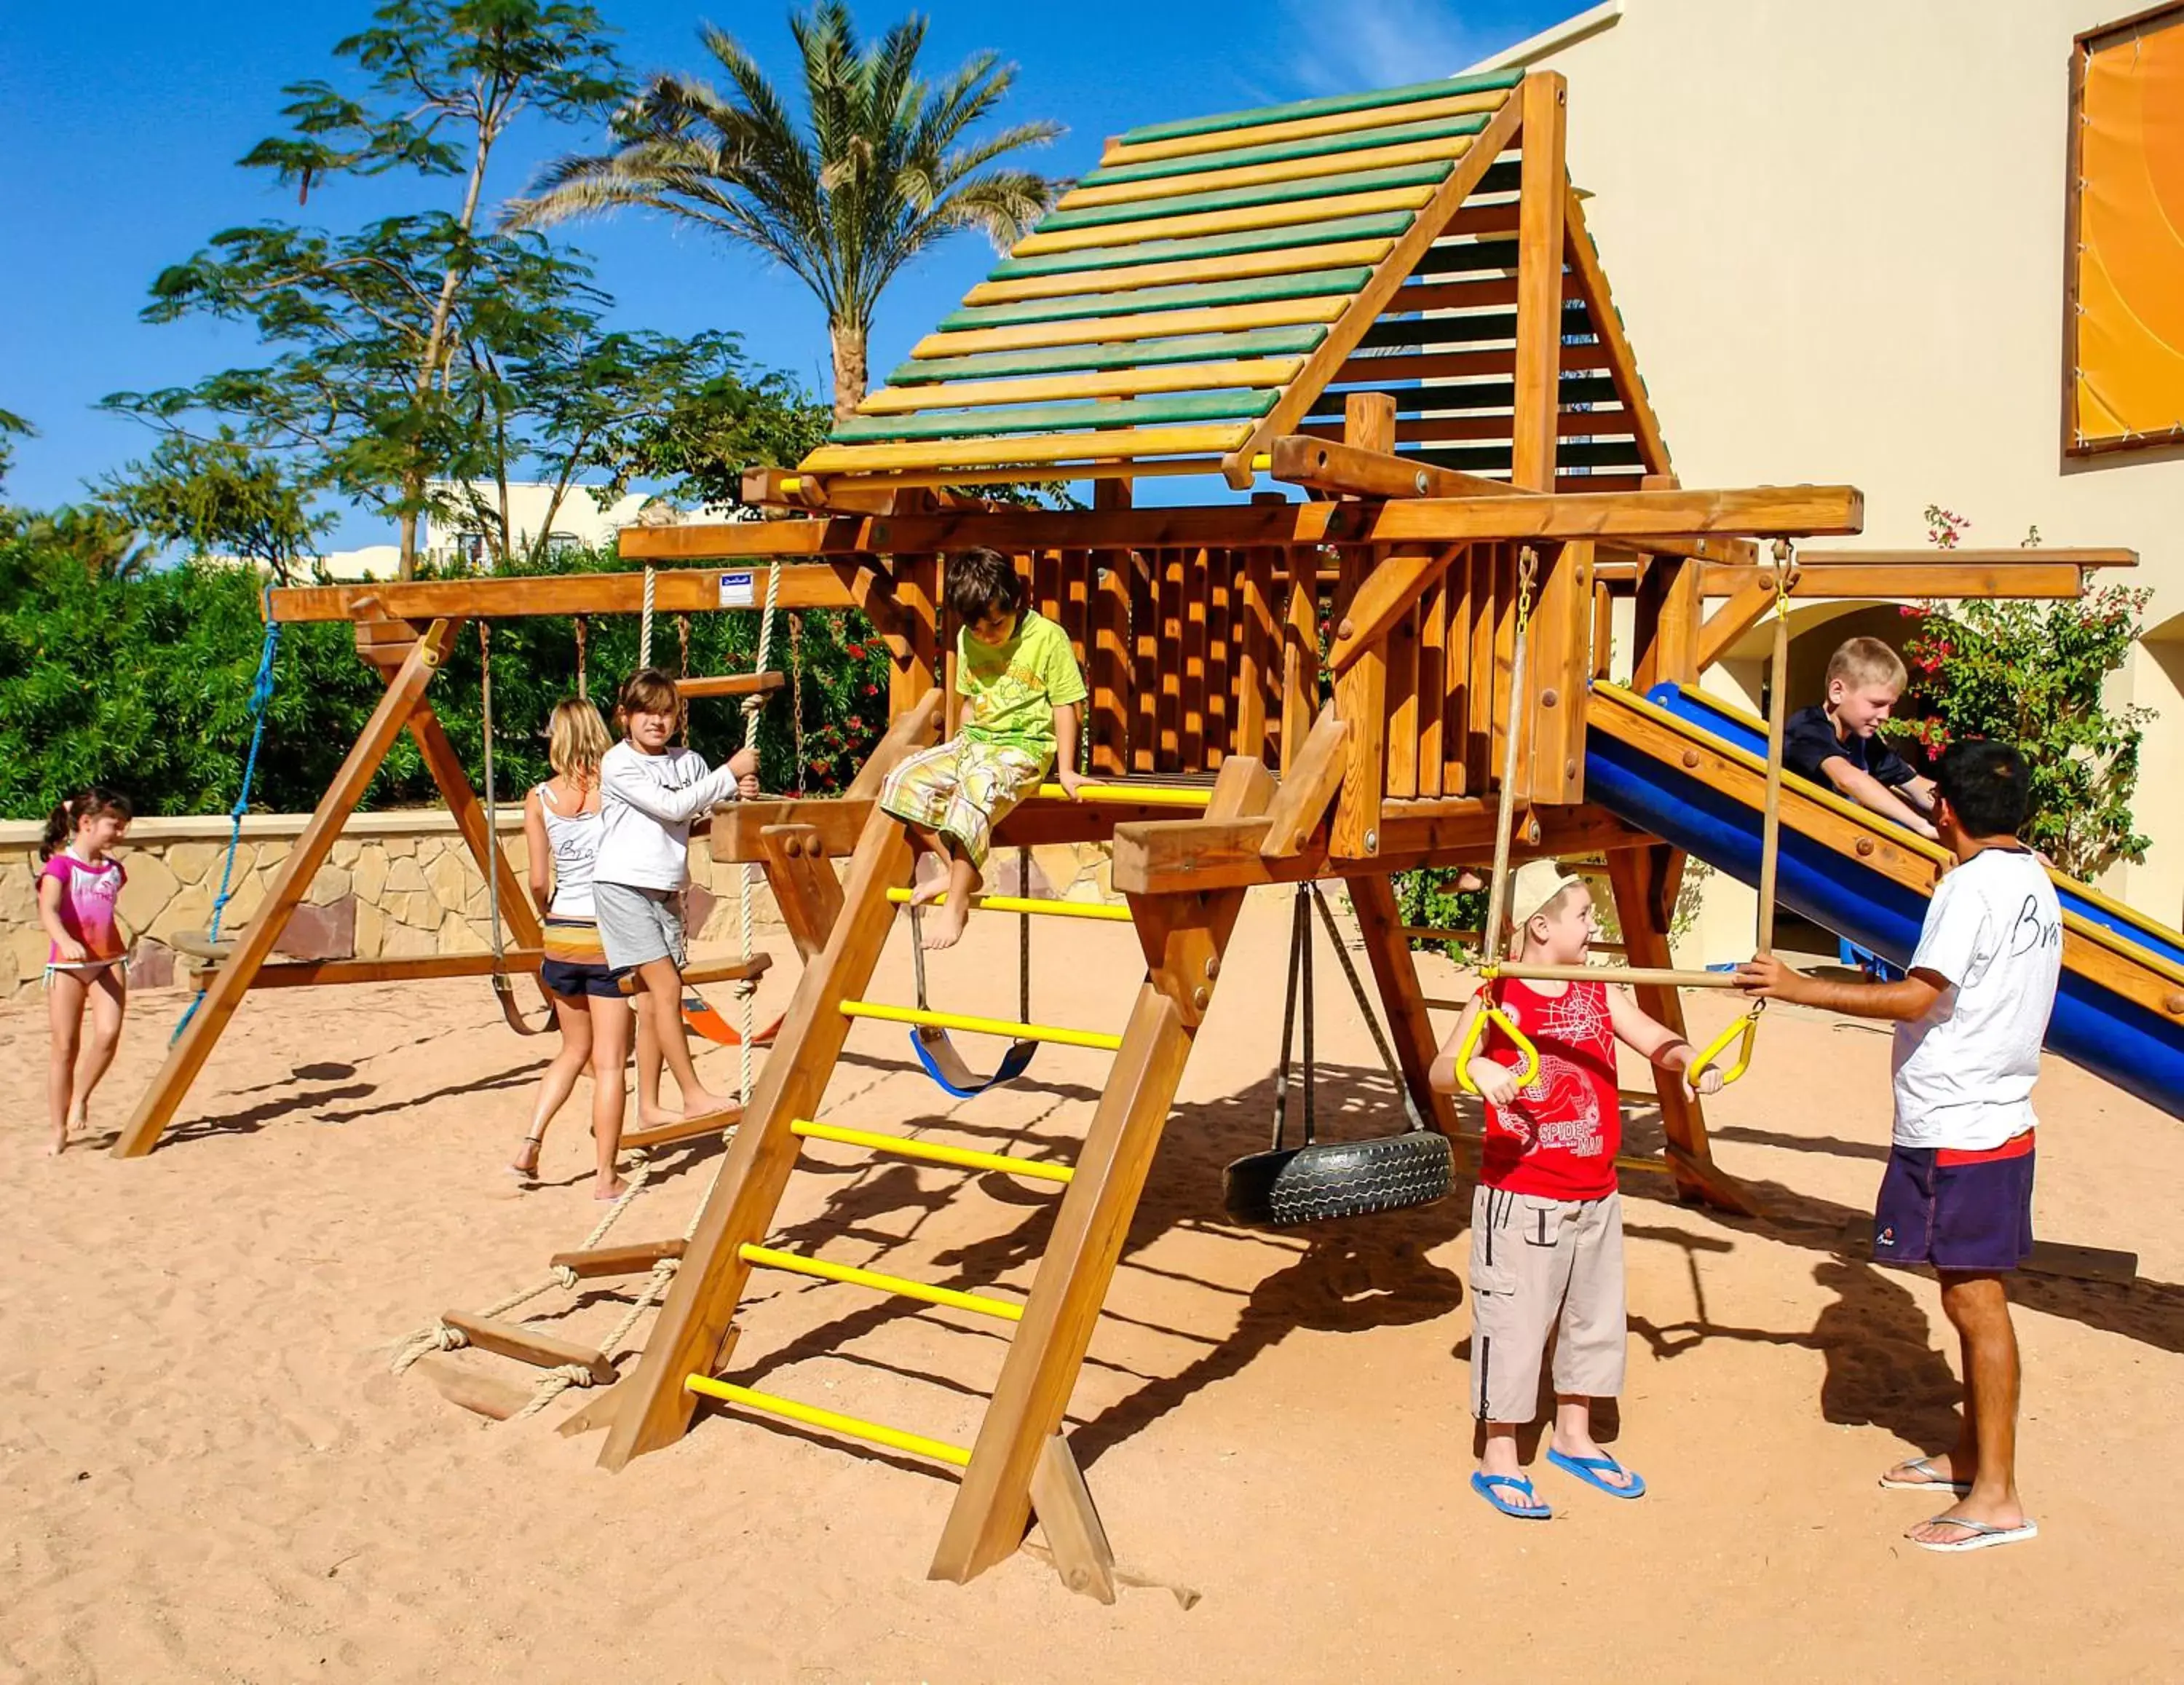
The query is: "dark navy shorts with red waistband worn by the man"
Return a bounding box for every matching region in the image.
[1874,1130,2033,1274]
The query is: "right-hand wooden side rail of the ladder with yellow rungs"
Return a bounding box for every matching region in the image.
[926,756,1273,1580]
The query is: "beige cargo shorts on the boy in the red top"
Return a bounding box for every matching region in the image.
[1470,1185,1625,1423]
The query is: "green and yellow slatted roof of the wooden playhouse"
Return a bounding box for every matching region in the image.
[797,72,1666,489]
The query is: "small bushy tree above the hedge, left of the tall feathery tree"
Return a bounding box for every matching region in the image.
[98,428,334,585]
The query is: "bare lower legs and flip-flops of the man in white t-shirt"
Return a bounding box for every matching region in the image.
[1880,1270,2029,1550]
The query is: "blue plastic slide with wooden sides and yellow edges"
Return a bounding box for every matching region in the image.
[1586,684,2184,1117]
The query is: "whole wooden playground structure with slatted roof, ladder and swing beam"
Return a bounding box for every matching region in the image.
[116,74,2127,1598]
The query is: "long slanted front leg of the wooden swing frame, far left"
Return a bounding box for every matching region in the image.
[114,618,463,1159]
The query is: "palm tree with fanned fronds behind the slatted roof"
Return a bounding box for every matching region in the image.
[509,0,1061,417]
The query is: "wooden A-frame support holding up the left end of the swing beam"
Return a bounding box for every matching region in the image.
[114,616,539,1159]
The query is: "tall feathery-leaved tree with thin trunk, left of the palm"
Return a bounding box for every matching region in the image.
[107,0,625,577]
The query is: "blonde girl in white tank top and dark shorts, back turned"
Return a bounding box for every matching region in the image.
[509,697,636,1200]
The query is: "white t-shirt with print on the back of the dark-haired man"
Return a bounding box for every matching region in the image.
[1894,848,2062,1152]
